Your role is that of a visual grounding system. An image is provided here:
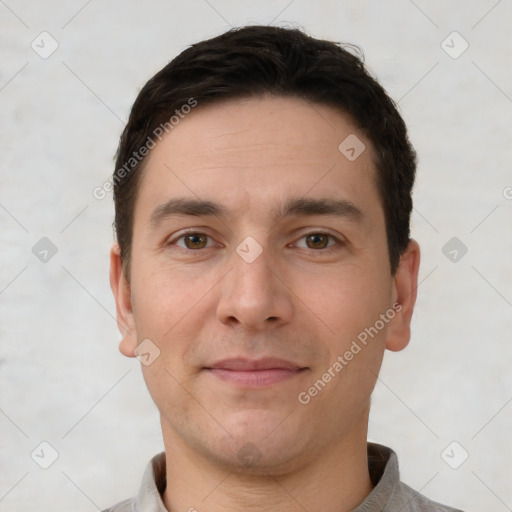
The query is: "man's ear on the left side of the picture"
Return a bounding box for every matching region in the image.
[110,243,137,357]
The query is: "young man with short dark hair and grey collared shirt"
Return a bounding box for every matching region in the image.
[105,26,464,512]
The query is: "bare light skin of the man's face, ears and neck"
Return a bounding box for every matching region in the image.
[111,96,420,512]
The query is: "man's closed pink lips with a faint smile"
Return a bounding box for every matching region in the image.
[204,358,308,388]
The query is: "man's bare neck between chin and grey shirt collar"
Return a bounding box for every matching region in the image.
[163,425,372,512]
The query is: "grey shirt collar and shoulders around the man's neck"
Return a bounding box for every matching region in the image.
[103,443,462,512]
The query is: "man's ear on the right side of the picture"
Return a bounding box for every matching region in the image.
[386,240,420,352]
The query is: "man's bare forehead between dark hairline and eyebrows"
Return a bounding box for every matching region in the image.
[136,96,382,226]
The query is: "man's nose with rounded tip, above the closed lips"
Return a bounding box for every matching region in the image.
[217,245,294,331]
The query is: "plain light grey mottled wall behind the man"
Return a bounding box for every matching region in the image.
[0,0,512,512]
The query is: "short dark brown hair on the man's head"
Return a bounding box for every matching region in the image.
[113,26,416,277]
